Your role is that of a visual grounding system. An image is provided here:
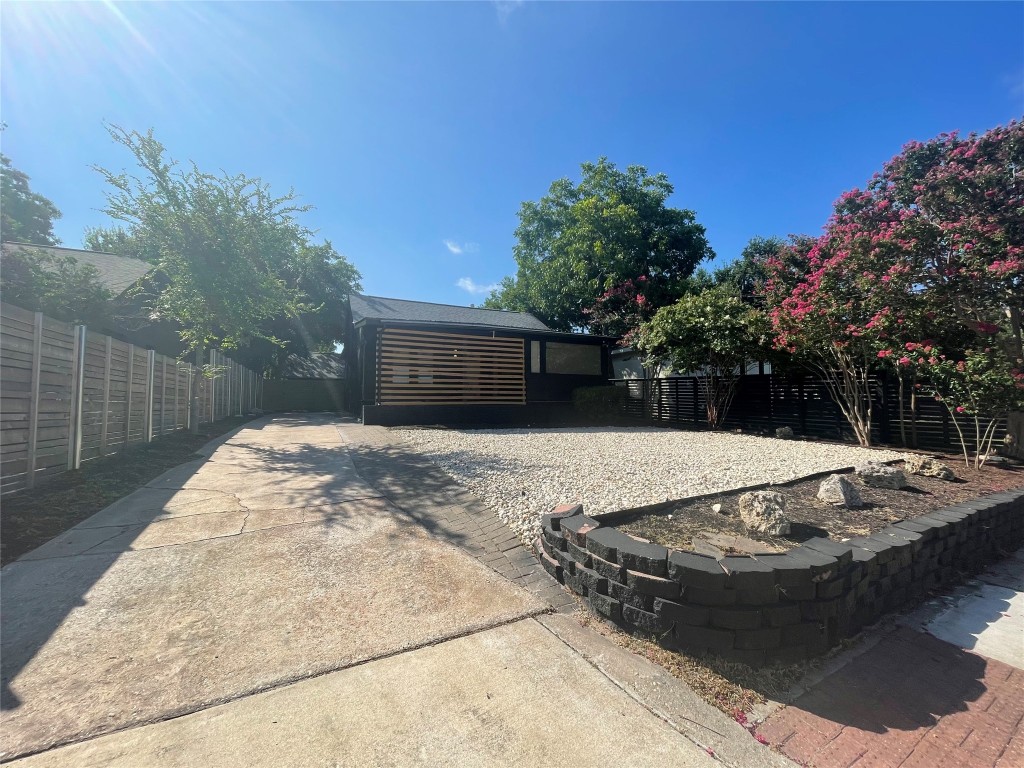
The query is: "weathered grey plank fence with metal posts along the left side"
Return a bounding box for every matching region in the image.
[0,303,263,496]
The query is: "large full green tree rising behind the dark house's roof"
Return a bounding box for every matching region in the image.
[484,158,714,331]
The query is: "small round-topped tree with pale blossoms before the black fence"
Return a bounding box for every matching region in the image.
[634,288,769,428]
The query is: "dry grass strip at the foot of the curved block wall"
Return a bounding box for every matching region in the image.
[577,606,816,717]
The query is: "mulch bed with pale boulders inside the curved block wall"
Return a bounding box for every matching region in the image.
[609,456,1024,555]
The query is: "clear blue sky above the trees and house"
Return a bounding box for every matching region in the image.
[0,2,1024,304]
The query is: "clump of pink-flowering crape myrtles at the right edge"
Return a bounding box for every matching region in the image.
[766,122,1024,456]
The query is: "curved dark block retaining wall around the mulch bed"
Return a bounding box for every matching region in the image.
[535,488,1024,667]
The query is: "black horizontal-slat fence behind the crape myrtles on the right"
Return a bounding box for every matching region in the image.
[612,374,1006,453]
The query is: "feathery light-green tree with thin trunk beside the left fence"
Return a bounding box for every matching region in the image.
[92,126,358,429]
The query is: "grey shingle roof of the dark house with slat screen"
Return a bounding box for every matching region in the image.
[348,294,551,331]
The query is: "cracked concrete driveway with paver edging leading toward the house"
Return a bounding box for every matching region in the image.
[0,416,788,766]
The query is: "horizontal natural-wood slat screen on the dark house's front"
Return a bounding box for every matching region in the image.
[377,329,526,406]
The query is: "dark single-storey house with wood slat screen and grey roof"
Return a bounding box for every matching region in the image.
[345,294,614,426]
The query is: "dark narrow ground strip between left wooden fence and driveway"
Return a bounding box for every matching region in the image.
[0,416,253,565]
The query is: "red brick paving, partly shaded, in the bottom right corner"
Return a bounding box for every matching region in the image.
[756,628,1024,768]
